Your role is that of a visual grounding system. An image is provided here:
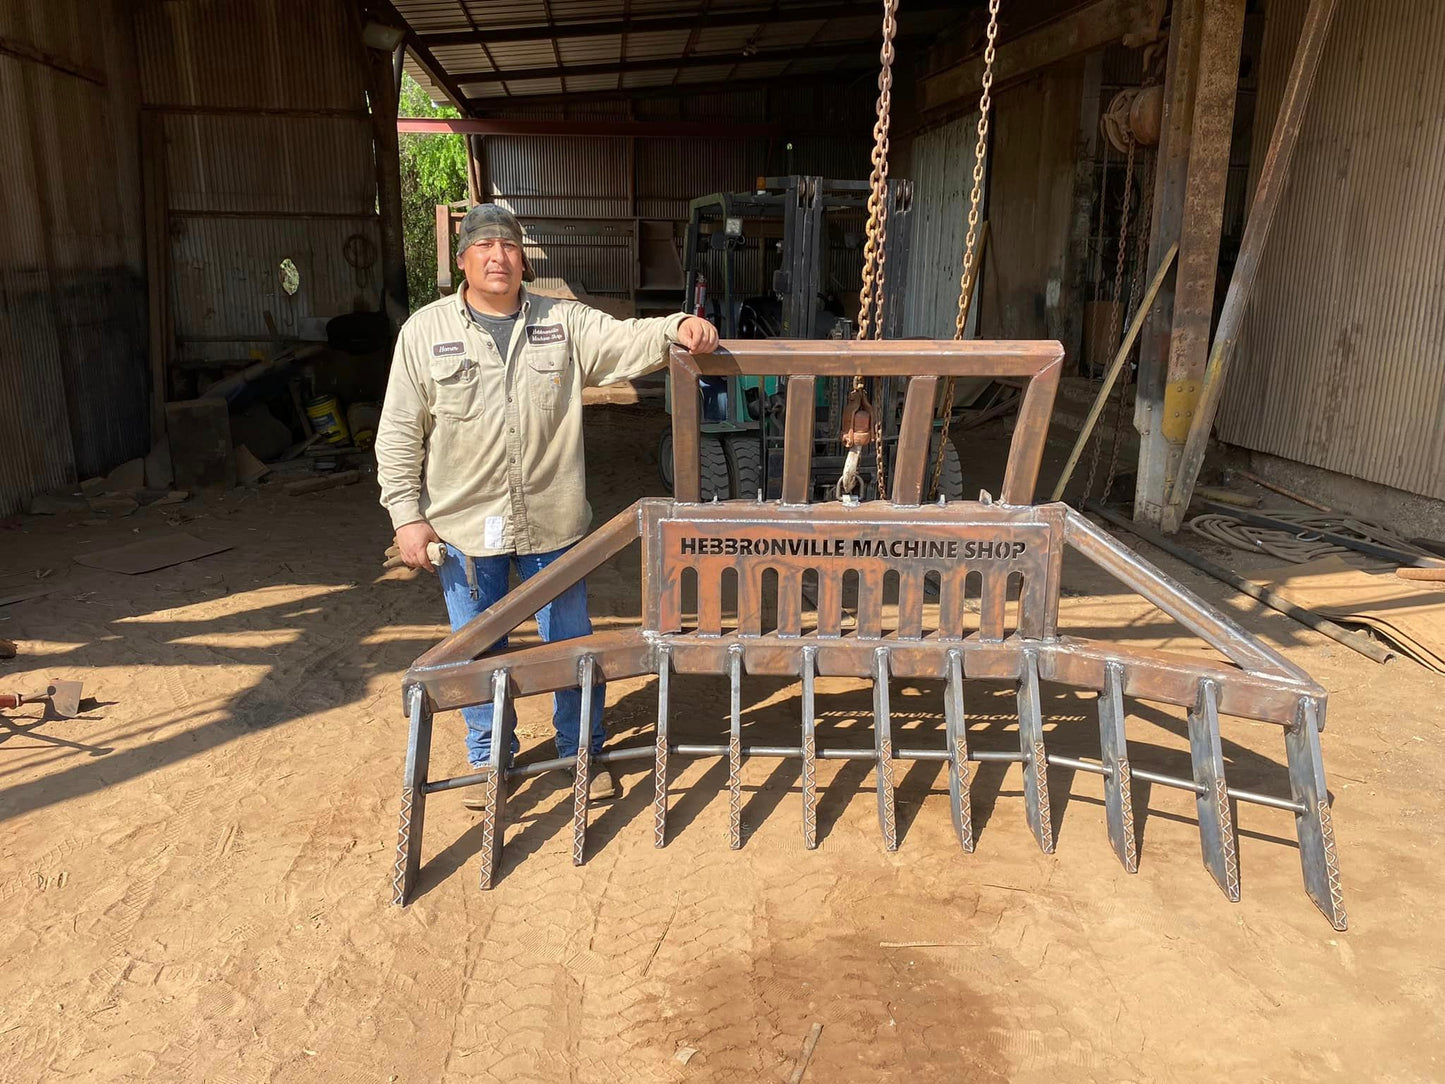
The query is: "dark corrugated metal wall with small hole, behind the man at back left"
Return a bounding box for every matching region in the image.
[134,0,381,364]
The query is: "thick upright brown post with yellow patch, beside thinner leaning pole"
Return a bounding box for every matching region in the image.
[1136,0,1244,522]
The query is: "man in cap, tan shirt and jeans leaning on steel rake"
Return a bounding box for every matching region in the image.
[376,204,718,808]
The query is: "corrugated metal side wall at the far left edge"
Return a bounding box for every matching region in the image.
[0,0,149,515]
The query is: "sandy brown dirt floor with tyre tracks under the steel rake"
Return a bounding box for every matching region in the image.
[0,406,1445,1084]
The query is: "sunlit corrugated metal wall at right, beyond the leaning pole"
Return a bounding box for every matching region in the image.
[1218,0,1445,499]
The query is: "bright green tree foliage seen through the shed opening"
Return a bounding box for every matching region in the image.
[397,75,467,312]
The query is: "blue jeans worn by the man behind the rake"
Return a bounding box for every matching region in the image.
[436,546,607,767]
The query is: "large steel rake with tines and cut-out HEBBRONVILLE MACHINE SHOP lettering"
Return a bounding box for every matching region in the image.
[393,341,1345,929]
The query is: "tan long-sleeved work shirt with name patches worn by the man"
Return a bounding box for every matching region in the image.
[376,289,686,556]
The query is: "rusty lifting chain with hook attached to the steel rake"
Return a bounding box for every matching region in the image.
[838,0,899,500]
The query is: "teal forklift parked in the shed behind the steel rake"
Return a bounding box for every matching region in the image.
[657,176,964,500]
